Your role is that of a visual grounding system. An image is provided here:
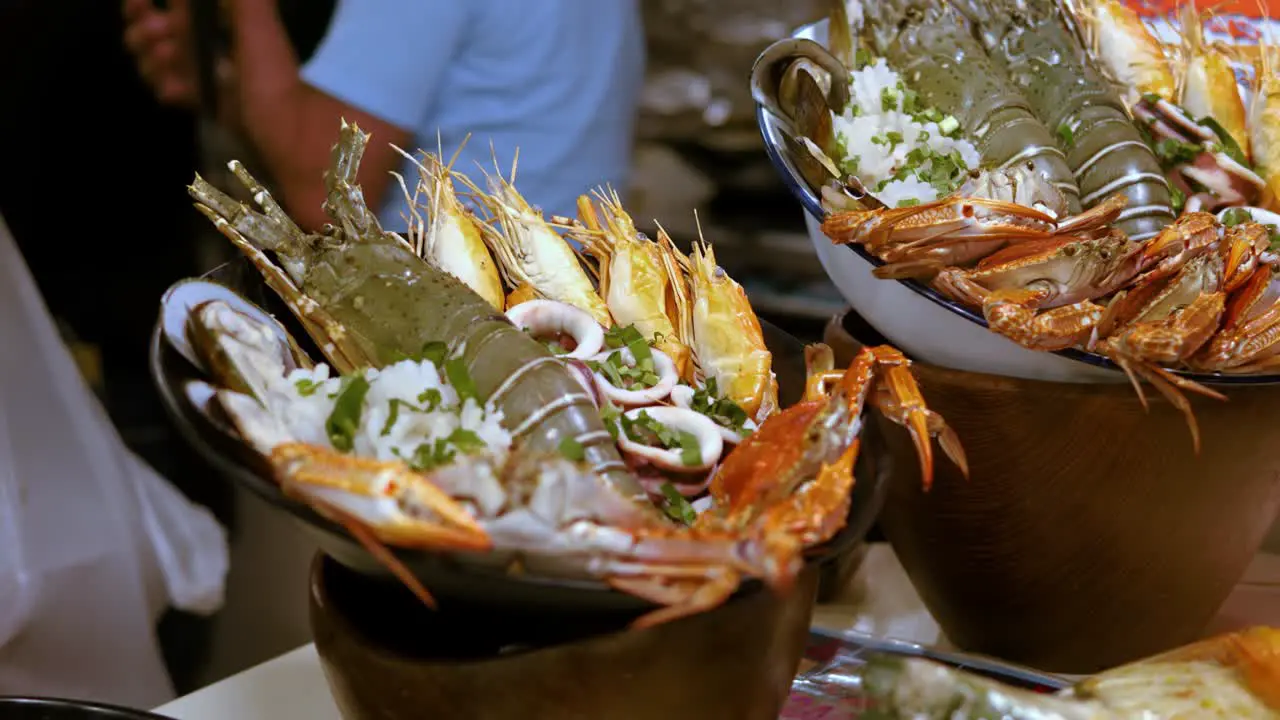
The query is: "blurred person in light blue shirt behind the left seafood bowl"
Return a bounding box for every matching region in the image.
[124,0,645,229]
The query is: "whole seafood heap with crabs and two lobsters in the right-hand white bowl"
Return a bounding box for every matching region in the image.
[751,0,1280,442]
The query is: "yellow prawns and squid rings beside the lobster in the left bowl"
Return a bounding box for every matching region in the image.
[391,144,777,504]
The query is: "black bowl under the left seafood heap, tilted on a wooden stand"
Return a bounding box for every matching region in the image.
[150,259,890,611]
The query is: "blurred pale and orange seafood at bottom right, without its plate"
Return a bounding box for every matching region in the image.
[858,626,1280,720]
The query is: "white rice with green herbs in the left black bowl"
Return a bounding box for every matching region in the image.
[254,360,511,464]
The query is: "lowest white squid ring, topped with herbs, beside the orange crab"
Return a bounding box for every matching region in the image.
[618,405,724,473]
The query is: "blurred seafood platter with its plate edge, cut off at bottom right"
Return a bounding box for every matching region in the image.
[782,626,1280,720]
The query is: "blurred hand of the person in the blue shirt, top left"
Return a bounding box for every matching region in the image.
[124,0,197,108]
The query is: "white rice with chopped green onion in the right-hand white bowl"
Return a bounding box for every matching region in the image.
[832,58,979,208]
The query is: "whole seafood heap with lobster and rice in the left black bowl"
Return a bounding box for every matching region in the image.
[170,123,966,626]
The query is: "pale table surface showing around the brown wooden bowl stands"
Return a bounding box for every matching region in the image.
[155,543,1280,720]
